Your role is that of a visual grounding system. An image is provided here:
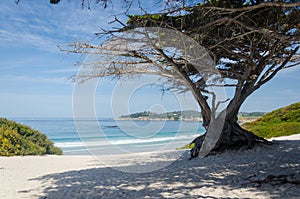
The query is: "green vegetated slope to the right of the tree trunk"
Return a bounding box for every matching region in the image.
[242,102,300,138]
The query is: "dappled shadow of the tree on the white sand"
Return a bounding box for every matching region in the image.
[30,140,300,199]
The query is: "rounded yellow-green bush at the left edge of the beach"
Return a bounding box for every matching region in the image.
[0,118,62,156]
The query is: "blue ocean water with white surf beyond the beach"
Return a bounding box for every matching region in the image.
[15,118,204,155]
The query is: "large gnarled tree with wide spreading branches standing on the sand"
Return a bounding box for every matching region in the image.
[63,0,300,158]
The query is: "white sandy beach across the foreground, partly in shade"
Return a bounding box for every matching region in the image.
[0,134,300,199]
